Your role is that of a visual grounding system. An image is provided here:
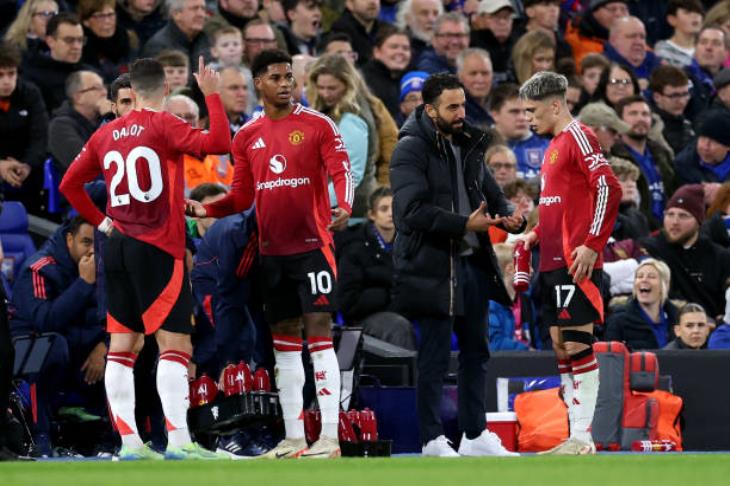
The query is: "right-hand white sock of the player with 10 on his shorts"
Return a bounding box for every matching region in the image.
[307,337,340,439]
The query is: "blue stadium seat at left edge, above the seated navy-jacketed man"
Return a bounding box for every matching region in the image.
[0,201,36,282]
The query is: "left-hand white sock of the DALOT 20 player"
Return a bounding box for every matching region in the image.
[104,352,142,449]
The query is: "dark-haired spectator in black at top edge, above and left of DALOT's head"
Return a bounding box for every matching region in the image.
[76,0,133,83]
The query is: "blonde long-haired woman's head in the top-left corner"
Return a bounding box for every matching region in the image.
[5,0,58,51]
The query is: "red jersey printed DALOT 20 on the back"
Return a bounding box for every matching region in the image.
[60,94,231,258]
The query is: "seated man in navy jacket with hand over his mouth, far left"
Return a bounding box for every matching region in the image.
[10,217,107,455]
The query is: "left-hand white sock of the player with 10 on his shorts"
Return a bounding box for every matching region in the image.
[273,334,304,439]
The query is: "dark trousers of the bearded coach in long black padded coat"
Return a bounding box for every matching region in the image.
[416,257,489,444]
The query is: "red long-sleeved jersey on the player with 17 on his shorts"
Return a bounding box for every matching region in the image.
[535,120,621,272]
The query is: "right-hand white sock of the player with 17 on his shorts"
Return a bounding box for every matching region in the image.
[571,352,599,442]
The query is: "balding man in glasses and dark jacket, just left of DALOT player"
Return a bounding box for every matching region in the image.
[48,71,112,174]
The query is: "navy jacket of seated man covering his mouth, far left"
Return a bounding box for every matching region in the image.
[10,220,101,350]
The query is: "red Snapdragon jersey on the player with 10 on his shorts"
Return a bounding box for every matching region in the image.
[206,105,354,255]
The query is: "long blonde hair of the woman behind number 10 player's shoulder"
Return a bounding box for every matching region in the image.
[307,54,360,123]
